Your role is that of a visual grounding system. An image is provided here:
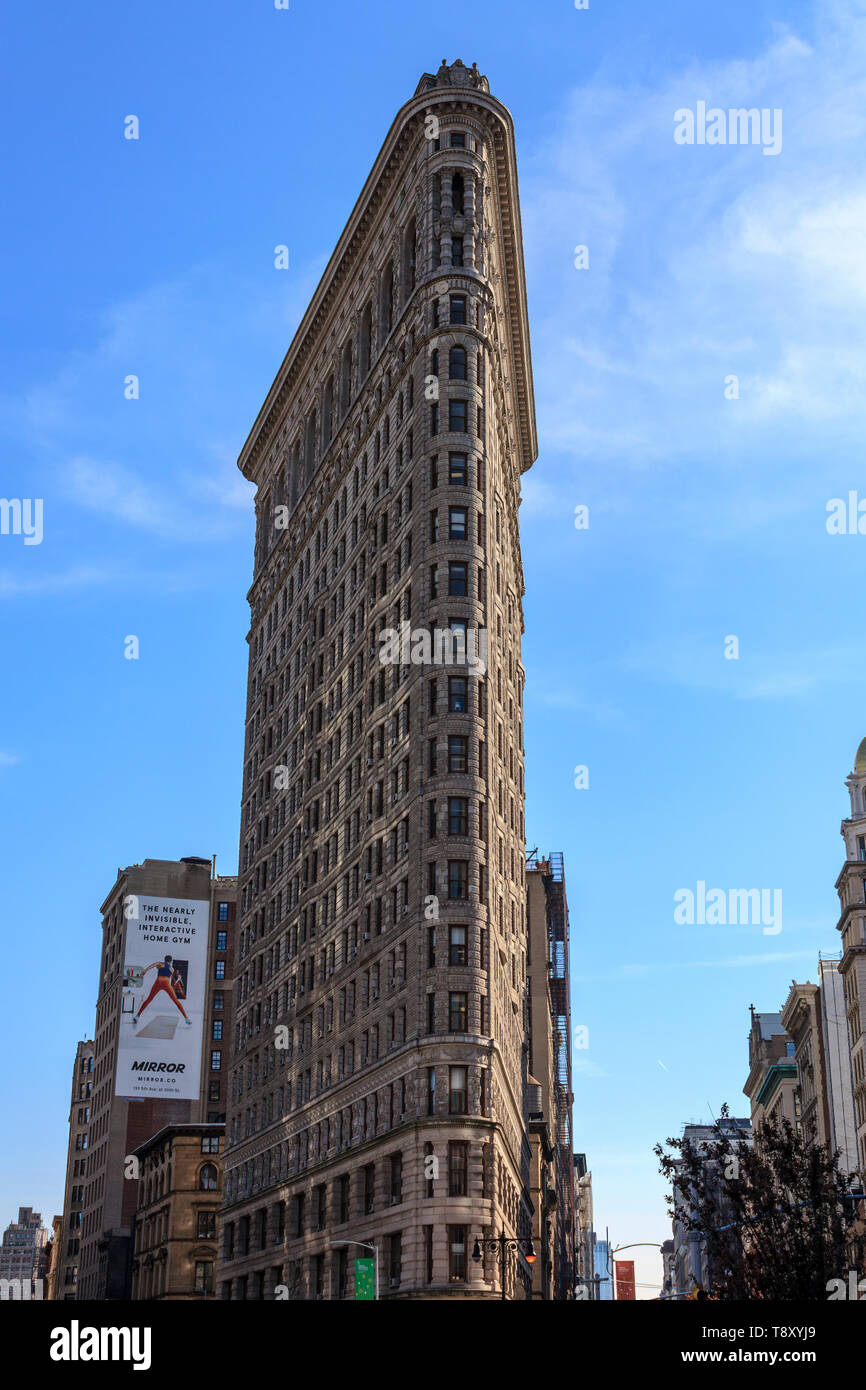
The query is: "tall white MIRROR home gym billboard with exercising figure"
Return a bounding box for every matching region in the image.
[114,894,210,1101]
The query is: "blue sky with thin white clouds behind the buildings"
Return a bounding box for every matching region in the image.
[0,0,866,1293]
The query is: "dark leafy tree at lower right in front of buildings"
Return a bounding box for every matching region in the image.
[653,1105,856,1301]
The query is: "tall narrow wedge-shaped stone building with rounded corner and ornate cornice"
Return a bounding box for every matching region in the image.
[217,61,537,1300]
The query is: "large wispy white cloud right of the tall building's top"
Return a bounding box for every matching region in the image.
[521,4,866,483]
